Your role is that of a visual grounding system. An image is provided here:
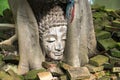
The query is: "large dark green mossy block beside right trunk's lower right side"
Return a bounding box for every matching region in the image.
[98,38,117,50]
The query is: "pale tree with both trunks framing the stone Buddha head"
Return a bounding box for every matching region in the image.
[6,0,96,74]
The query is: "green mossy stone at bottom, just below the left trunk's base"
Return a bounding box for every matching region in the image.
[24,69,46,80]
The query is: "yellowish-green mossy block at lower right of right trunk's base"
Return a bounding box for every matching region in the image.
[89,55,109,66]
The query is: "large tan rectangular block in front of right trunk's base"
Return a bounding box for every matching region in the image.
[67,67,90,80]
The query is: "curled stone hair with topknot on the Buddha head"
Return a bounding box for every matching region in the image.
[38,6,67,38]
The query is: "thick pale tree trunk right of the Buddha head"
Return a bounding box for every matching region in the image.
[65,0,96,67]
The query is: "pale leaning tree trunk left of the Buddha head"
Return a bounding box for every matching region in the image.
[9,0,44,74]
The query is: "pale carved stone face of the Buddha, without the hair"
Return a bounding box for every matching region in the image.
[42,26,67,60]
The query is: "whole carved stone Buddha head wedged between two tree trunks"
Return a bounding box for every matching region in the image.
[39,6,67,61]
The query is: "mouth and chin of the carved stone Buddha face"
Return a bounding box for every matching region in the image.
[48,52,63,61]
